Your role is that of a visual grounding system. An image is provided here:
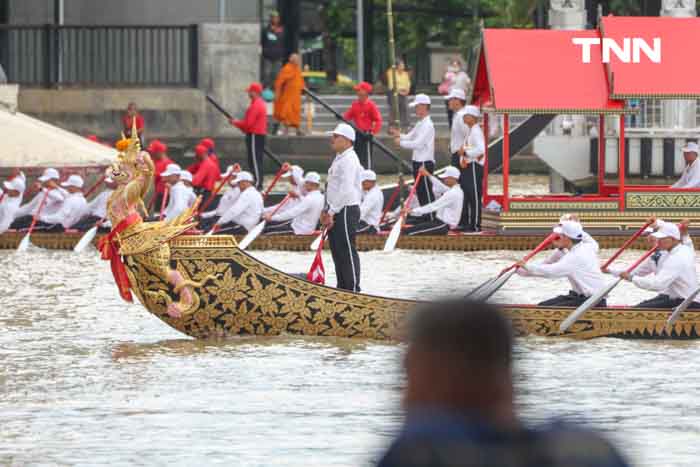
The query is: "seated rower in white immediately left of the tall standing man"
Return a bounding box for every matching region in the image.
[263,172,324,235]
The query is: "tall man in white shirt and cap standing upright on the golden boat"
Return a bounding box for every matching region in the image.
[321,123,363,292]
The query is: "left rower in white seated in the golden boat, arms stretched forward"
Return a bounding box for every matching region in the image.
[517,221,606,307]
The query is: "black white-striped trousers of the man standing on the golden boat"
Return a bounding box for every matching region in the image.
[328,205,360,292]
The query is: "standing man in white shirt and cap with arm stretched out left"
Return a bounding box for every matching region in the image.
[394,94,435,220]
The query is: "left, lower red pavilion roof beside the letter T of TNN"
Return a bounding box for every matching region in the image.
[472,29,625,114]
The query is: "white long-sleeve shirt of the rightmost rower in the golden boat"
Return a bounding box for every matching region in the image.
[632,243,700,301]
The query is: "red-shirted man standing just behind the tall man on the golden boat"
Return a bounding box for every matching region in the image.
[343,81,382,169]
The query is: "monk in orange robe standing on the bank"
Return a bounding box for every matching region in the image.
[274,54,304,135]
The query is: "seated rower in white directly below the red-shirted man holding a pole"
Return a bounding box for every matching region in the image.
[214,171,263,235]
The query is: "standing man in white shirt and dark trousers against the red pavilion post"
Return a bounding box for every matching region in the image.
[460,105,486,232]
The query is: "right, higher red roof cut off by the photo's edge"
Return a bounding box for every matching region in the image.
[600,16,700,99]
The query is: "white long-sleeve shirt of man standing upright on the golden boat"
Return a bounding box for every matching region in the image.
[326,147,364,214]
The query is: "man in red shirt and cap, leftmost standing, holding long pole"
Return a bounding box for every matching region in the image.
[229,83,267,190]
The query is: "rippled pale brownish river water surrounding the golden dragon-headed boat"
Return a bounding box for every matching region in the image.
[0,245,700,467]
